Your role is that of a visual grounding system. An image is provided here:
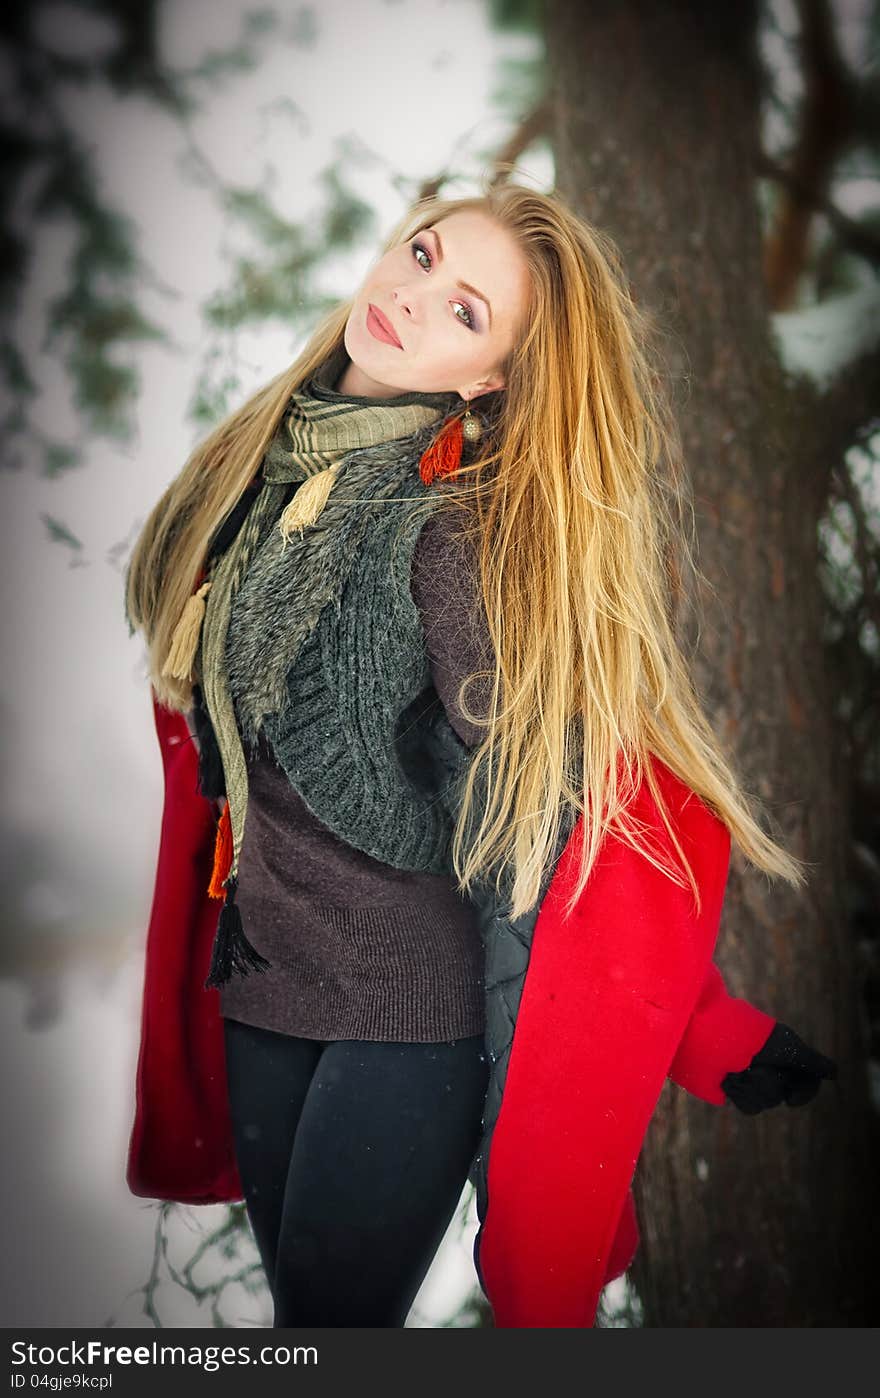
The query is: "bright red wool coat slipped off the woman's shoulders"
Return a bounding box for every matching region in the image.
[126,695,775,1328]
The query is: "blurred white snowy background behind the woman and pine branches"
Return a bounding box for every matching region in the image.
[0,0,880,1328]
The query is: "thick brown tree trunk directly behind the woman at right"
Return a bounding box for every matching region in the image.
[546,0,879,1327]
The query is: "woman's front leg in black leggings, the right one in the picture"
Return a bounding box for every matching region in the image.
[274,1035,488,1327]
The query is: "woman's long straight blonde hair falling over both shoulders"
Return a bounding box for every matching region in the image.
[126,183,806,917]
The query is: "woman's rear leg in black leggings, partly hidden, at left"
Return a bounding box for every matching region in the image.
[224,1019,322,1290]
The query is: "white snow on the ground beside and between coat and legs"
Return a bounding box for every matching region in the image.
[0,938,486,1329]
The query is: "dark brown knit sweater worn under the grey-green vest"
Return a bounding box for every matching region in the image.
[220,512,491,1042]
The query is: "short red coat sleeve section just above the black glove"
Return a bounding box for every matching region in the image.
[669,962,776,1106]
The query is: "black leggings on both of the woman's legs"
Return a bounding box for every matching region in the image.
[224,1019,488,1327]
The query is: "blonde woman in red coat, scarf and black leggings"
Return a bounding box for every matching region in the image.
[126,185,835,1327]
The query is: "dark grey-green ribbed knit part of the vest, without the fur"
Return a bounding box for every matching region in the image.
[250,480,464,874]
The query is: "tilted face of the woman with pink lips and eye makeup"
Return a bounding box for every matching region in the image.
[336,208,529,398]
